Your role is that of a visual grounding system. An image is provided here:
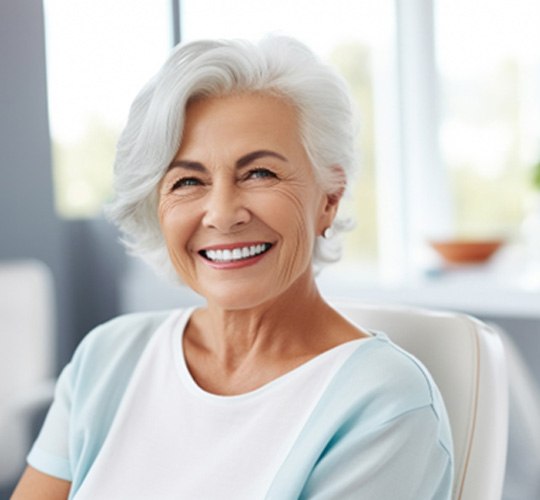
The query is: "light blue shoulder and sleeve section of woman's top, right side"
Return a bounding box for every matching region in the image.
[269,334,452,498]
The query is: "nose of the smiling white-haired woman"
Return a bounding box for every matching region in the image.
[202,182,251,233]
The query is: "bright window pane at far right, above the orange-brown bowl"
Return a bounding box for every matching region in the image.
[436,0,540,238]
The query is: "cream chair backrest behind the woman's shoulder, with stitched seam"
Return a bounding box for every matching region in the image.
[334,302,508,500]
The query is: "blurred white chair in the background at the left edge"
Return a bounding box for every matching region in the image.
[0,260,55,489]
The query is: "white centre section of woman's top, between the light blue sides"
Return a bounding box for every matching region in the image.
[77,311,364,500]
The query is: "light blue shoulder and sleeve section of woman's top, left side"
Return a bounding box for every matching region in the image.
[27,311,172,491]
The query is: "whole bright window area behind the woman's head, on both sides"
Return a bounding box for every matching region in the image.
[44,0,540,286]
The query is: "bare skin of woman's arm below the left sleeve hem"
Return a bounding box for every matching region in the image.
[11,466,71,500]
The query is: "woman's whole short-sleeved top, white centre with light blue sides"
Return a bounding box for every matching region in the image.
[28,311,453,500]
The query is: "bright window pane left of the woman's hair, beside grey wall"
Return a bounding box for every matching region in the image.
[44,0,172,217]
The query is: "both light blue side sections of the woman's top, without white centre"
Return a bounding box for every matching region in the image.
[28,312,453,500]
